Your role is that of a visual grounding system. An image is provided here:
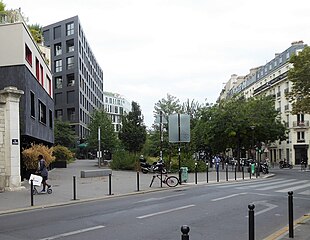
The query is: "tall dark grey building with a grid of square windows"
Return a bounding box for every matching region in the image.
[43,16,103,139]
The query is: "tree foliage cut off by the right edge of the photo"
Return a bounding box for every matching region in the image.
[286,46,310,114]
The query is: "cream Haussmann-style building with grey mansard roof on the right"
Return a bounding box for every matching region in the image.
[220,41,310,164]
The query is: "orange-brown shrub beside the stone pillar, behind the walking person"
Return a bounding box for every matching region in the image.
[22,144,55,170]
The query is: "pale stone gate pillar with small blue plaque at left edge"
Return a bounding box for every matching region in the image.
[0,87,24,192]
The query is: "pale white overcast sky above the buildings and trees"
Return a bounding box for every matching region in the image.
[3,0,310,127]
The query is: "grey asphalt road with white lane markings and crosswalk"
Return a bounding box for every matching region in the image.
[0,169,310,240]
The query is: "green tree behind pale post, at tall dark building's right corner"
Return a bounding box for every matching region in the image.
[87,110,117,153]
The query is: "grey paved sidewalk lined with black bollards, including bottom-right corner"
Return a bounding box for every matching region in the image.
[0,160,310,240]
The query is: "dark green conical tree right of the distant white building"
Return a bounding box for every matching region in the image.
[118,102,146,153]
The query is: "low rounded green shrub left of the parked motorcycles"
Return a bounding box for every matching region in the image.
[110,151,138,170]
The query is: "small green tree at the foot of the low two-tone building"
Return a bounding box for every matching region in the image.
[54,120,77,148]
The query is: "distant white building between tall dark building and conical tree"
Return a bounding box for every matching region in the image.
[103,92,131,132]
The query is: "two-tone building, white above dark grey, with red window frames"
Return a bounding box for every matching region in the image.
[0,11,54,148]
